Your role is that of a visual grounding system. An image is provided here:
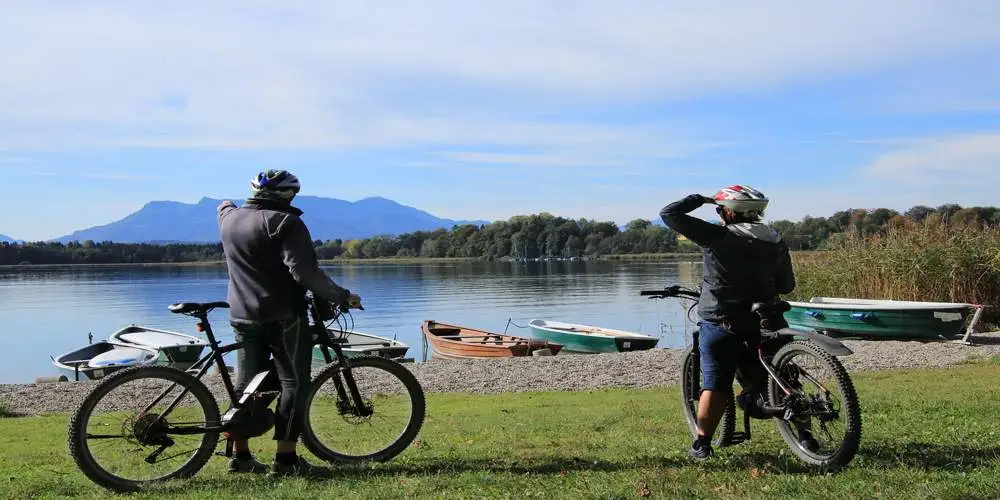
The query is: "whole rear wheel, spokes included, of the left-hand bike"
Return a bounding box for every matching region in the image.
[68,366,219,492]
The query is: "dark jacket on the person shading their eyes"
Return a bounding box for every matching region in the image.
[660,194,795,322]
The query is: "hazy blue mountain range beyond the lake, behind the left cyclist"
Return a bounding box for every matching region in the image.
[54,196,487,243]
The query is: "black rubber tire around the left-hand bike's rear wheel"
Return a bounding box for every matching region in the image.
[67,366,219,493]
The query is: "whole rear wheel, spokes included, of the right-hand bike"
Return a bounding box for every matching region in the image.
[767,340,861,469]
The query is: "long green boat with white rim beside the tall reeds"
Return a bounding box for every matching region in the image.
[785,297,982,340]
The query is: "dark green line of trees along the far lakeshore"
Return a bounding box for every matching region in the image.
[0,204,1000,265]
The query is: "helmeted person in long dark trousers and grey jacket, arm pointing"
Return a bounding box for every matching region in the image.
[218,169,361,476]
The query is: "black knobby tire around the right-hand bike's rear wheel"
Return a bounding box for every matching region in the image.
[767,340,861,470]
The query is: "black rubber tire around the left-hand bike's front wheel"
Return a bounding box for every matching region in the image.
[302,356,426,464]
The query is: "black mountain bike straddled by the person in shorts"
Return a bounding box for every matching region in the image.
[640,285,861,470]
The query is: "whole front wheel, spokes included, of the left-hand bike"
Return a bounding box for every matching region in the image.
[302,356,424,463]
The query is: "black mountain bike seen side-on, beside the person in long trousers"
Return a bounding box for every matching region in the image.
[69,297,424,492]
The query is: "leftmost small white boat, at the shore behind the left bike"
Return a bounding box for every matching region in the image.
[52,340,159,381]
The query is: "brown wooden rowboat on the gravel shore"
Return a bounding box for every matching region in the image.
[421,320,562,358]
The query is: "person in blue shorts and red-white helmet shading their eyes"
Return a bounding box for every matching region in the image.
[660,185,795,459]
